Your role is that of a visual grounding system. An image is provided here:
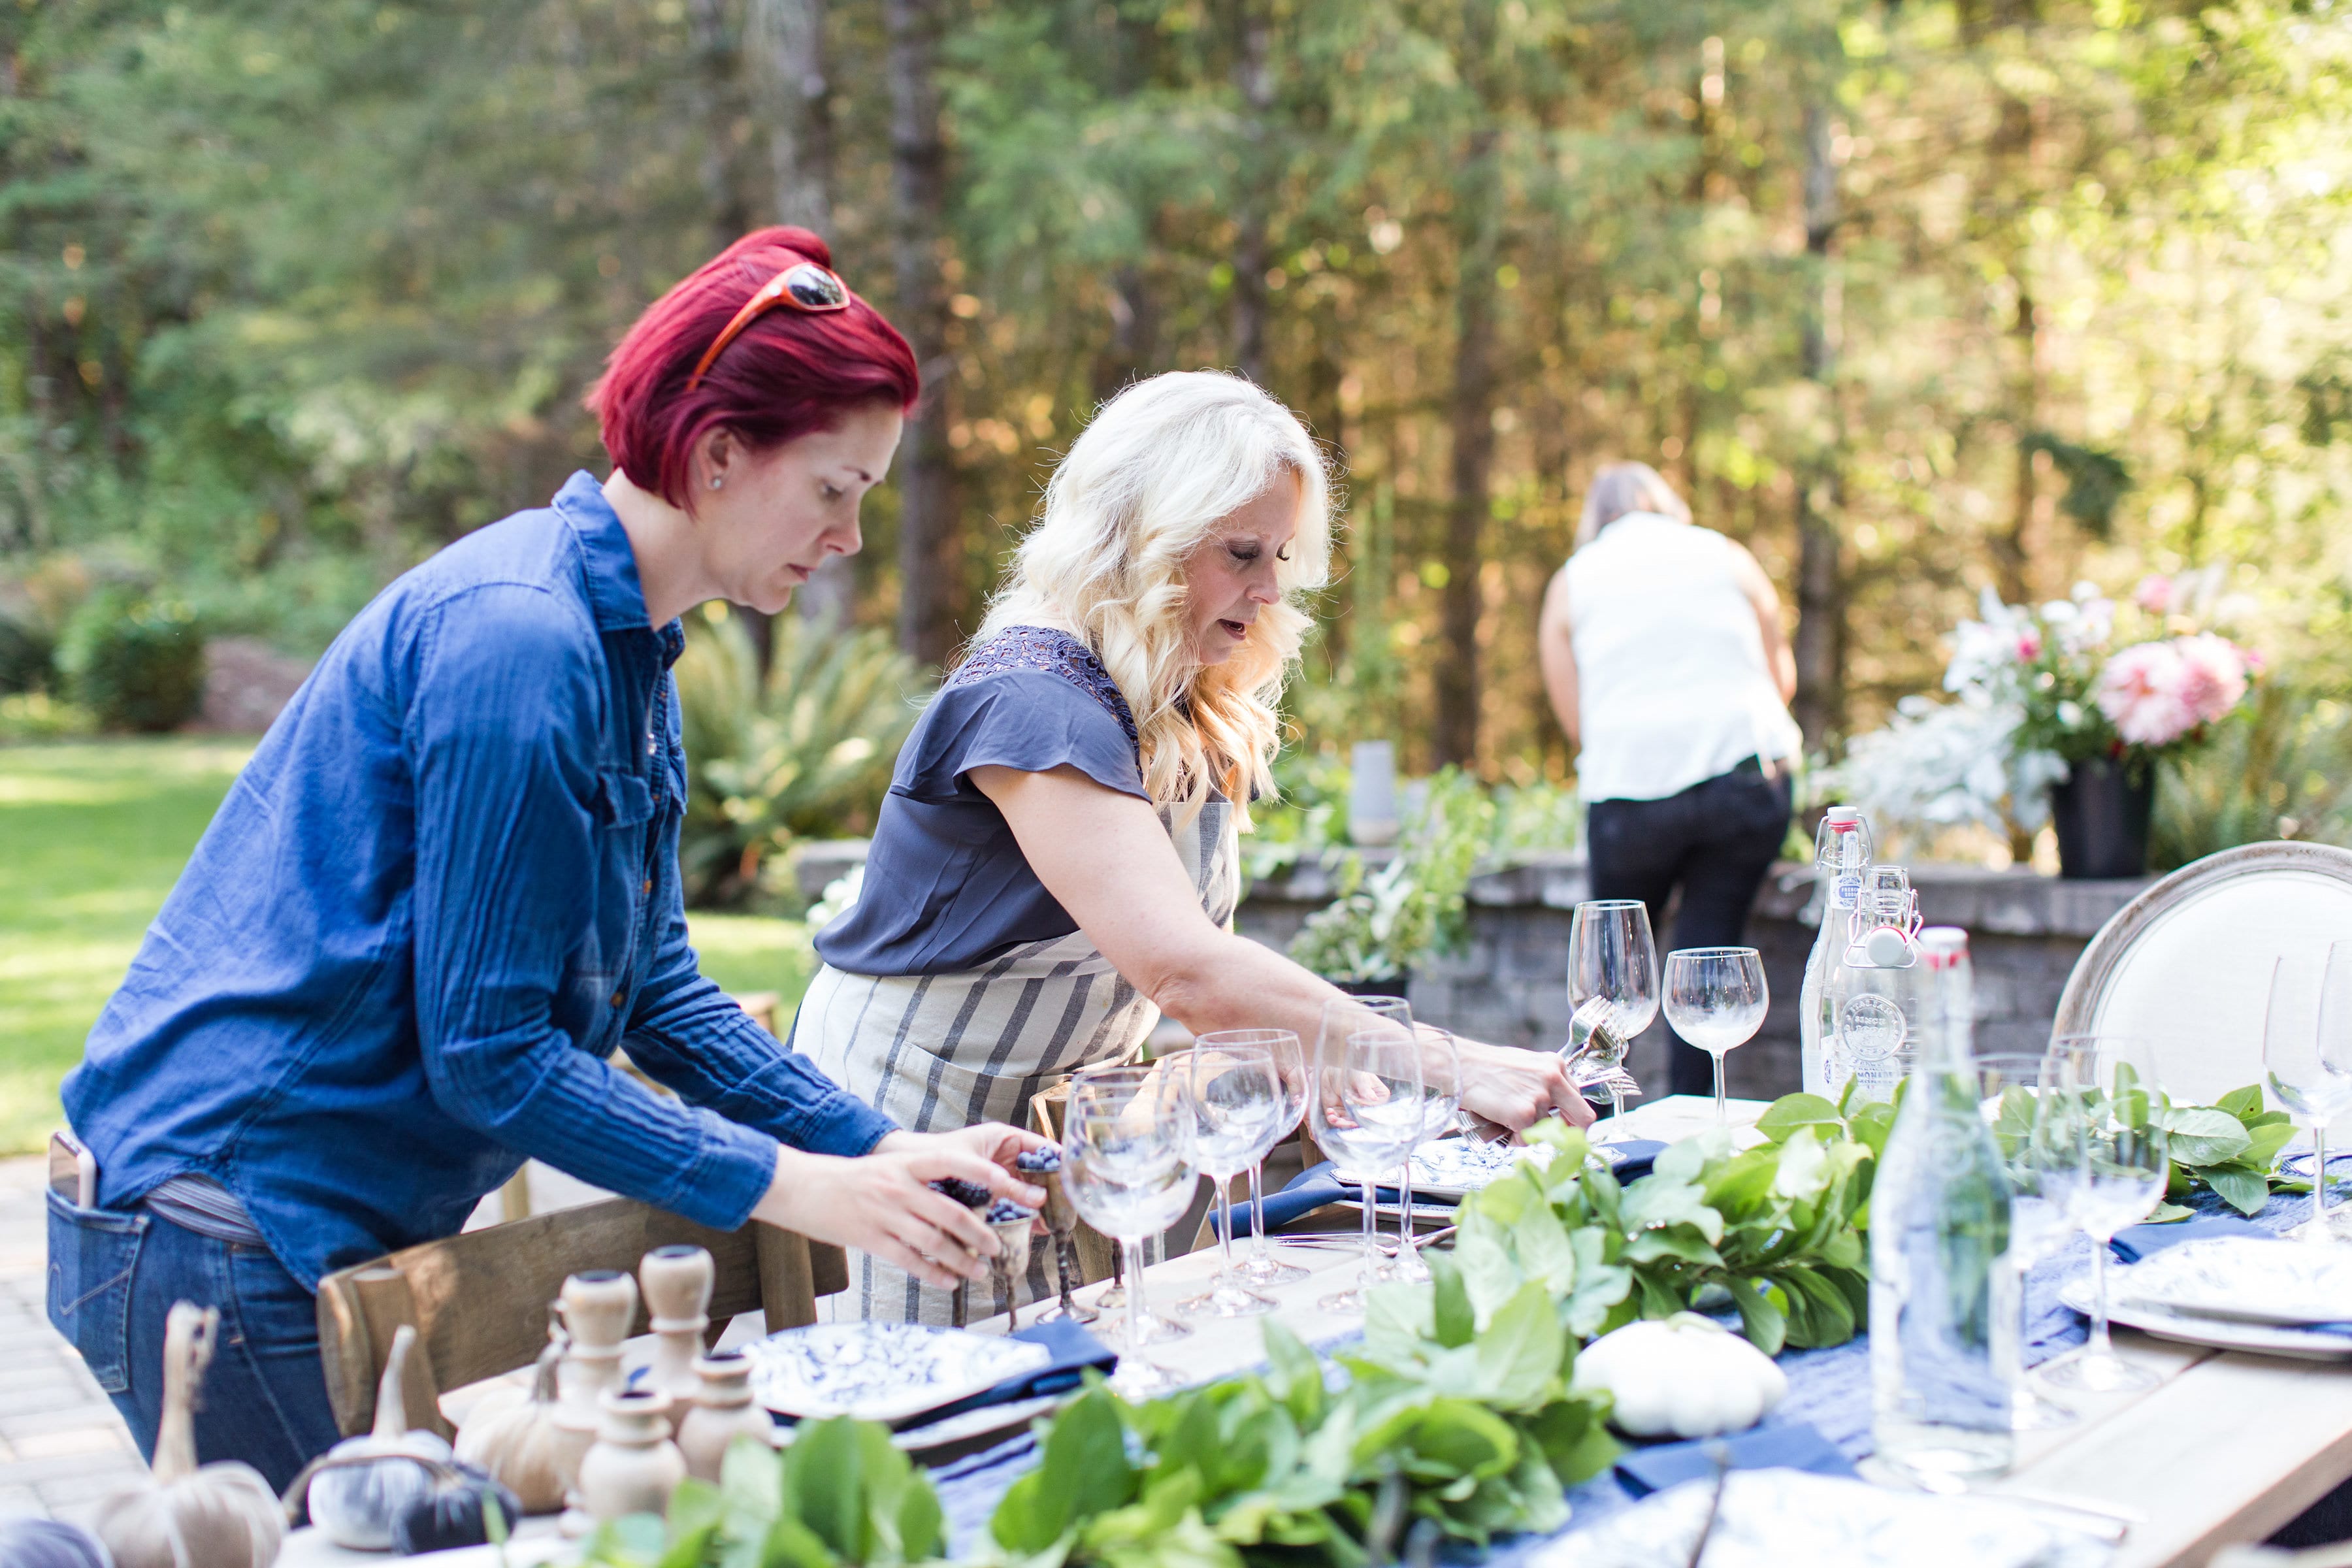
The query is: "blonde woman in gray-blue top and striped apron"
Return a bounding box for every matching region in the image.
[792,372,1592,1321]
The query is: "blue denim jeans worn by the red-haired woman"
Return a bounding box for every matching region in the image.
[47,1192,338,1490]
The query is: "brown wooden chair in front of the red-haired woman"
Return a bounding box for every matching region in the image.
[318,1199,849,1437]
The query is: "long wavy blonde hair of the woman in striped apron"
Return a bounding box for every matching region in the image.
[973,372,1331,825]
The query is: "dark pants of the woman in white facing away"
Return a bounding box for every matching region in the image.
[1585,762,1795,1096]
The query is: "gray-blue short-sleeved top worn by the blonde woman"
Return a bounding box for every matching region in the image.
[816,625,1150,975]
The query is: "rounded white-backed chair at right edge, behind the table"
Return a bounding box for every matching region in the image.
[2053,841,2352,1105]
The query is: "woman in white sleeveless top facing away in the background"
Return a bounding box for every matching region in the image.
[1538,463,1802,1093]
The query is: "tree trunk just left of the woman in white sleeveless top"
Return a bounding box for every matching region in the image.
[1432,125,1496,766]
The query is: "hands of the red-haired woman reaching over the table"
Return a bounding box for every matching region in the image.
[753,1121,1044,1290]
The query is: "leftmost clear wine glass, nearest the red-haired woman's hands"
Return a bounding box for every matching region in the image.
[1061,1062,1197,1399]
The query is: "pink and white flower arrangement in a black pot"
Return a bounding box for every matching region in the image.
[1832,566,2262,837]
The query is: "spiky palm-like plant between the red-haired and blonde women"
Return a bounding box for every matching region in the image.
[678,606,929,905]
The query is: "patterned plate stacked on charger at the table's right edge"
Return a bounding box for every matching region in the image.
[2058,1237,2352,1361]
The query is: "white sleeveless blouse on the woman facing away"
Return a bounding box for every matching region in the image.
[1567,512,1804,802]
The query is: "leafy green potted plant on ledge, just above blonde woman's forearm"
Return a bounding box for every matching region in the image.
[1291,769,1494,997]
